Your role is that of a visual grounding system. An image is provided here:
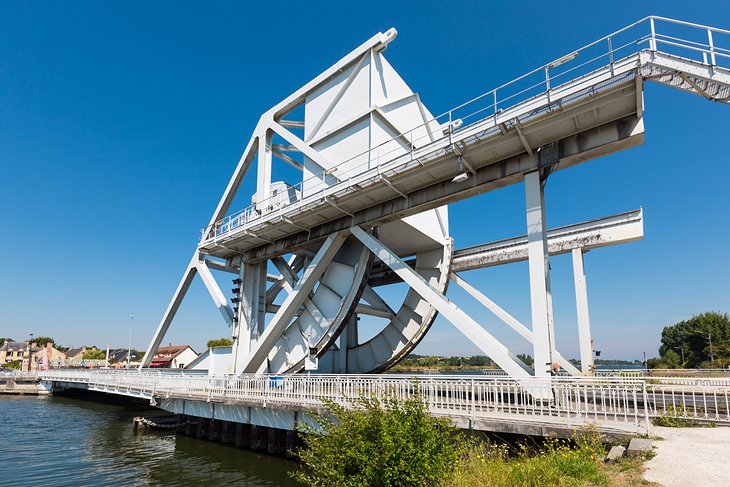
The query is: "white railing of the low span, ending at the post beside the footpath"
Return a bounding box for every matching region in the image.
[42,370,649,433]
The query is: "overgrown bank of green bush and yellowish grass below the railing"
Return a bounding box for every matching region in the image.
[292,397,650,487]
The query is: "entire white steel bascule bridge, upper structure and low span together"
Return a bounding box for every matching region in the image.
[14,17,730,448]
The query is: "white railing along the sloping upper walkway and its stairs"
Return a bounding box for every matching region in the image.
[201,16,730,242]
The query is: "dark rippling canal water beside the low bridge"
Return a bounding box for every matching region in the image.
[0,395,298,487]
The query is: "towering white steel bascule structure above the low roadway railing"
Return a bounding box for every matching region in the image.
[142,17,730,378]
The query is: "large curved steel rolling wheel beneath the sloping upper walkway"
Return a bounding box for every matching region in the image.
[253,212,453,374]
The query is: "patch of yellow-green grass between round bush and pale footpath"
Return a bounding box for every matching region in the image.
[444,431,653,487]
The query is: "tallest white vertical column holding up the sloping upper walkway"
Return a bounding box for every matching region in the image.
[525,171,555,377]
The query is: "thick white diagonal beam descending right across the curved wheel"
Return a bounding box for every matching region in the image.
[350,227,530,377]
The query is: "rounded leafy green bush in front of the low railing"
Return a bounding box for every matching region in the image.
[291,396,463,487]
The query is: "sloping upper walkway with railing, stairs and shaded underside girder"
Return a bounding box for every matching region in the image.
[198,17,730,264]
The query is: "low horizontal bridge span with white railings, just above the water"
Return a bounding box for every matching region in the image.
[32,369,730,438]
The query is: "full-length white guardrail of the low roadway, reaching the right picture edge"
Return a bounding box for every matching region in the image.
[39,369,730,432]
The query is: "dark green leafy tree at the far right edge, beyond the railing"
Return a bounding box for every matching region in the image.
[659,311,730,368]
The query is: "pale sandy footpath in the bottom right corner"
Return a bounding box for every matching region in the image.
[644,426,730,487]
